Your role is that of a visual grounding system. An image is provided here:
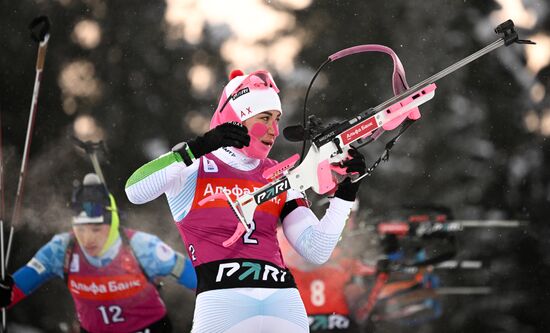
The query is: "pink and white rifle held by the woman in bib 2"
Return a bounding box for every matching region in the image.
[199,20,535,247]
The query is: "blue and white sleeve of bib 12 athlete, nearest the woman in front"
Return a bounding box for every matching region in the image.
[130,231,197,289]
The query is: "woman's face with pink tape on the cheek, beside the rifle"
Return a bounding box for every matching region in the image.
[243,110,281,159]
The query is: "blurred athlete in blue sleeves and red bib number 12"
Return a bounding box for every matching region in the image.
[0,174,197,332]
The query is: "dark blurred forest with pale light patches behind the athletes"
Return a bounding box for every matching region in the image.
[0,0,550,332]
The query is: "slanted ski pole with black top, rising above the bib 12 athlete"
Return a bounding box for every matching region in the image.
[2,16,50,267]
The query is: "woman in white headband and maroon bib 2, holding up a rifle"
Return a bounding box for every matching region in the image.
[126,71,365,333]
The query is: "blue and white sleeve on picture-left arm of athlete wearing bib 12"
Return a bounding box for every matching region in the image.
[13,233,70,295]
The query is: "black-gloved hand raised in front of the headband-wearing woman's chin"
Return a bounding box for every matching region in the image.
[187,121,250,158]
